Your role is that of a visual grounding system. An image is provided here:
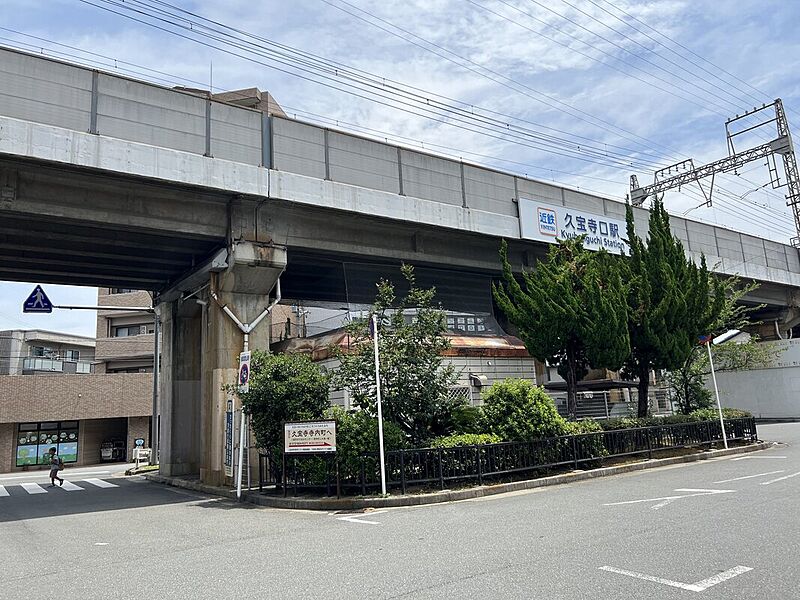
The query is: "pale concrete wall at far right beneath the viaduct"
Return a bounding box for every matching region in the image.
[706,340,800,419]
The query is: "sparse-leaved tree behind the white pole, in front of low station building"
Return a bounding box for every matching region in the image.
[334,265,465,445]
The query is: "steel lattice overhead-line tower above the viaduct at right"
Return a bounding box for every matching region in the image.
[630,98,800,248]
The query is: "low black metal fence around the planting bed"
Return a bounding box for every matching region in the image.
[259,418,757,495]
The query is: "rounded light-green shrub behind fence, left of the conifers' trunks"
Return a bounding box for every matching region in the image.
[483,379,566,442]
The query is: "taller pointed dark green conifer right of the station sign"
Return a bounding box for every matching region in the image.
[626,199,725,417]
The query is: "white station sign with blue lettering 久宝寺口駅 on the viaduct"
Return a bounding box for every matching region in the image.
[519,198,629,254]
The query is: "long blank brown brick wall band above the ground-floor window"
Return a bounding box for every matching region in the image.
[0,373,153,423]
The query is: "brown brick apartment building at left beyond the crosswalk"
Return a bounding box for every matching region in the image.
[0,289,154,472]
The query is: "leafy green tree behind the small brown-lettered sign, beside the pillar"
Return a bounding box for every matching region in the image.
[241,350,330,456]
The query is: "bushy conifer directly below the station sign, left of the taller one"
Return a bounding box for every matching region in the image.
[492,238,630,418]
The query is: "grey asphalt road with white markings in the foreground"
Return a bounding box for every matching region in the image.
[0,424,800,600]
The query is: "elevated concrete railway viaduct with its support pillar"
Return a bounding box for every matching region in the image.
[0,49,800,483]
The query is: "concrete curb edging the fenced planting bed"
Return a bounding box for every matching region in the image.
[142,442,772,510]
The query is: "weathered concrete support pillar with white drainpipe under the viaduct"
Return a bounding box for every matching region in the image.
[159,241,286,485]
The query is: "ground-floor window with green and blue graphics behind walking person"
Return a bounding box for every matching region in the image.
[17,421,78,467]
